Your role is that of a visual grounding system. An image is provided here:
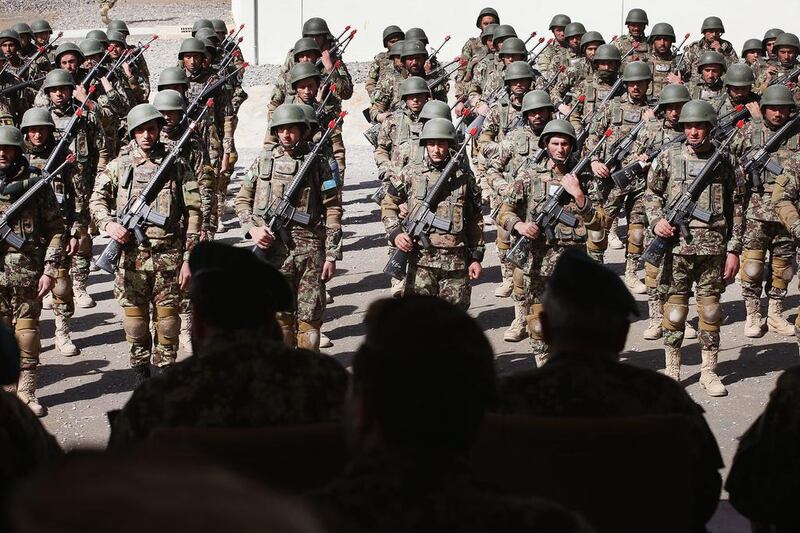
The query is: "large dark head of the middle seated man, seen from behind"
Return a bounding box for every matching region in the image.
[348,296,497,453]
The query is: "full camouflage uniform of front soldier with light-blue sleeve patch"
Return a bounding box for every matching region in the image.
[234,143,342,350]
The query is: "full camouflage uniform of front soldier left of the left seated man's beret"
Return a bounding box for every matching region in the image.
[90,141,202,367]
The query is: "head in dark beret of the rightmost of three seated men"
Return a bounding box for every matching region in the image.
[541,249,639,357]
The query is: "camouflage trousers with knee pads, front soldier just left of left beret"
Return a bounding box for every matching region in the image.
[114,243,183,366]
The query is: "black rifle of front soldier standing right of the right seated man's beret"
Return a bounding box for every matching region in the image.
[642,121,744,267]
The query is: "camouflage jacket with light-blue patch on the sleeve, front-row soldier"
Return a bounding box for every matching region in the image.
[234,143,342,261]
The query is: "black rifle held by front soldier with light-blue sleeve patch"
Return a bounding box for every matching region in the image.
[253,111,347,259]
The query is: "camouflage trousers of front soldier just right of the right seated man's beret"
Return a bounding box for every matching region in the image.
[661,254,725,350]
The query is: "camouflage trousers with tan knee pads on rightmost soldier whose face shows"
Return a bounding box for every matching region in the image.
[741,218,795,308]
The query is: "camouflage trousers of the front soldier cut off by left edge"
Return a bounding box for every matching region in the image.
[0,251,44,370]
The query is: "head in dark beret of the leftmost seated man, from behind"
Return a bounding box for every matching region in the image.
[189,242,294,340]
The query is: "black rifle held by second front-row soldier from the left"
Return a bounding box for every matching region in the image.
[96,99,214,274]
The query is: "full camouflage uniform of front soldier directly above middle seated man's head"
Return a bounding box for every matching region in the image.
[381,156,484,309]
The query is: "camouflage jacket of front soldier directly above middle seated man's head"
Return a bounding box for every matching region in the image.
[381,155,484,270]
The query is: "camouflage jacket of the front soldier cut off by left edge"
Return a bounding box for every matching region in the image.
[0,157,65,278]
